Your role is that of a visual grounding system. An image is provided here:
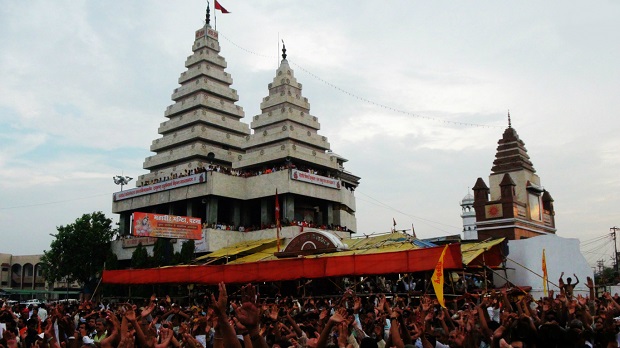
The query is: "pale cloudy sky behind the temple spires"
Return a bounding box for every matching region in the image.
[0,0,620,264]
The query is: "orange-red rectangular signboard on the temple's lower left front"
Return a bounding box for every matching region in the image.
[132,212,202,239]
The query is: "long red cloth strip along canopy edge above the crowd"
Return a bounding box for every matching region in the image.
[103,244,463,284]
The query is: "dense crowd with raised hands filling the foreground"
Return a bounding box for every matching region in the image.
[0,278,620,348]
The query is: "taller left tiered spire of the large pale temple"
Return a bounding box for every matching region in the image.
[137,23,250,185]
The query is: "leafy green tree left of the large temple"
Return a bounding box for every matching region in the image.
[41,211,118,286]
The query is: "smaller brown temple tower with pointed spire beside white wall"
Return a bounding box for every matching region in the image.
[473,113,556,240]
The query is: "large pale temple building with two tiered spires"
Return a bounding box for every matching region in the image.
[112,21,360,259]
